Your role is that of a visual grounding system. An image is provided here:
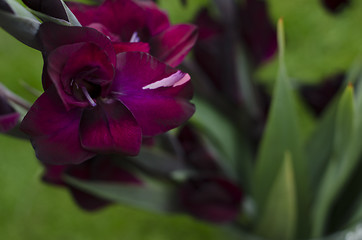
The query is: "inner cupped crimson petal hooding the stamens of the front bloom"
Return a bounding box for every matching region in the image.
[47,43,114,110]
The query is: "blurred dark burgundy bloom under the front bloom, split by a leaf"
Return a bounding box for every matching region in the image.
[43,156,142,211]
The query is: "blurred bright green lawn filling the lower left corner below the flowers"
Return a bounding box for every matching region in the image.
[0,135,224,240]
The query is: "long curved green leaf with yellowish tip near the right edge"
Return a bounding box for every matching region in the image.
[312,84,362,237]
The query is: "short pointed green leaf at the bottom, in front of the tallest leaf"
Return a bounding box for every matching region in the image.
[256,152,298,240]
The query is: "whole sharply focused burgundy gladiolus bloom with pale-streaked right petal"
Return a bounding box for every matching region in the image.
[21,23,194,164]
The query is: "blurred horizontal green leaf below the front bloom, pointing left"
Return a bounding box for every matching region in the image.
[64,175,180,213]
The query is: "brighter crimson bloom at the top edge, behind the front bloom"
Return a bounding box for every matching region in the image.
[68,0,197,67]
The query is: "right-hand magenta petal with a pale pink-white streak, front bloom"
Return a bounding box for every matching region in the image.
[111,52,195,136]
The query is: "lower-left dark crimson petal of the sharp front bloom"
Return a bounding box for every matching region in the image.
[20,87,94,164]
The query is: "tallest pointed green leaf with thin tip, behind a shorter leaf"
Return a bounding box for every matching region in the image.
[253,20,309,236]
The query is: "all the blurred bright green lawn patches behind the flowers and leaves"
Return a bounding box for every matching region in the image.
[0,0,362,240]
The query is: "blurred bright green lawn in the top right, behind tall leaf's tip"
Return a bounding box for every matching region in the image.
[257,0,362,83]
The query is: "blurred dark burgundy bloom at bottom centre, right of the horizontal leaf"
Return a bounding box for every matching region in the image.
[180,177,243,223]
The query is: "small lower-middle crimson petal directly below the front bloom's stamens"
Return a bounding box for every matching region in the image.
[80,100,142,155]
